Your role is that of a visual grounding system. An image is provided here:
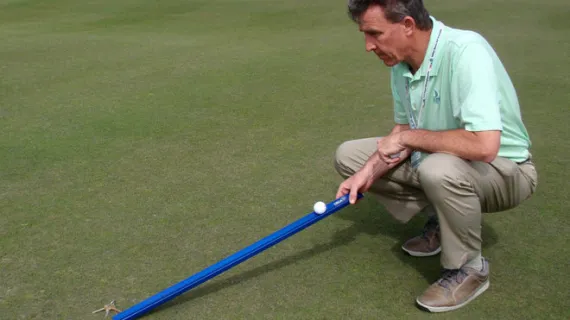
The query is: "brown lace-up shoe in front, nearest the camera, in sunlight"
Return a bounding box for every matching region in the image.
[416,258,489,312]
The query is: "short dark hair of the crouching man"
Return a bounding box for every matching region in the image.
[348,0,433,30]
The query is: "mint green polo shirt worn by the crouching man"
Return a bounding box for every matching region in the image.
[391,17,531,162]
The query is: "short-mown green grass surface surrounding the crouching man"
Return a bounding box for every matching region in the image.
[0,0,570,320]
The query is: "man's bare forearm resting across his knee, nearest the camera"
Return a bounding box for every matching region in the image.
[401,129,500,162]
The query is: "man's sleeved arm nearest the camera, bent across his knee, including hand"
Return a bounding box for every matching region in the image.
[379,41,503,162]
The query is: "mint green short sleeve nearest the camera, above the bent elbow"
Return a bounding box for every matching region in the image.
[452,43,503,131]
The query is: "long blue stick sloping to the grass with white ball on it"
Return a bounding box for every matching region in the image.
[113,194,362,320]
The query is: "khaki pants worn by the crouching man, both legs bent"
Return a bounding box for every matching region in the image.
[335,138,537,269]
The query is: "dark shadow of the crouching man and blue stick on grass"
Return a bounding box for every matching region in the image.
[151,199,498,313]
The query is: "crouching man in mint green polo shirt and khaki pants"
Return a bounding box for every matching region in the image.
[335,0,537,312]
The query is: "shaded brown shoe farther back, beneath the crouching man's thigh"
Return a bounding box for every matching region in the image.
[402,216,441,257]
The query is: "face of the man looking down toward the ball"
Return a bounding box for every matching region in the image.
[359,6,409,67]
